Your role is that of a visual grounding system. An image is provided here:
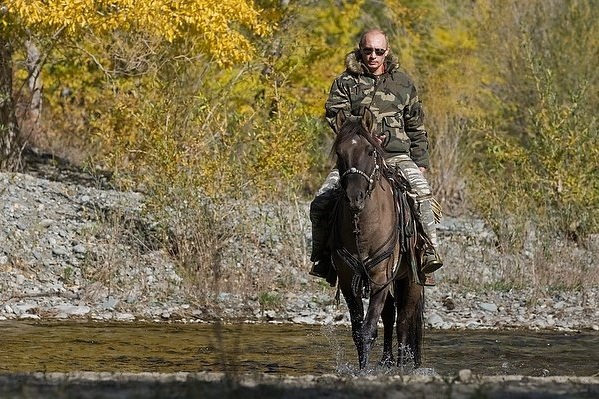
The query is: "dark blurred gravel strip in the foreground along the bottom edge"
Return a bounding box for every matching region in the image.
[0,370,599,399]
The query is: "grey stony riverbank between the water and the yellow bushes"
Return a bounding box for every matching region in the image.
[0,173,599,331]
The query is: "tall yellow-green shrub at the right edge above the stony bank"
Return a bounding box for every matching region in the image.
[470,0,599,245]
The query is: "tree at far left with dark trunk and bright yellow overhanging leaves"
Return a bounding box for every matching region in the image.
[0,0,272,170]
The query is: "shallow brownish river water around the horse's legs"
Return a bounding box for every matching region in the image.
[0,321,599,376]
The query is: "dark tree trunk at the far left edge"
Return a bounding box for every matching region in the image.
[0,30,21,171]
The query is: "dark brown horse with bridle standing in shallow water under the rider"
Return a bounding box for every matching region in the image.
[331,109,424,369]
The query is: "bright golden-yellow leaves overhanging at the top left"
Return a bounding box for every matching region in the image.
[6,0,274,65]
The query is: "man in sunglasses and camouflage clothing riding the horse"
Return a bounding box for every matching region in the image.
[310,29,443,285]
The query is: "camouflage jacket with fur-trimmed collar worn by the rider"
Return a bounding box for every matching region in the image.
[325,50,429,168]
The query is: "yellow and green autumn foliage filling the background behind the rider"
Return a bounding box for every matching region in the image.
[1,0,599,241]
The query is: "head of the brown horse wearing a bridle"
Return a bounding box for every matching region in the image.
[332,108,382,212]
